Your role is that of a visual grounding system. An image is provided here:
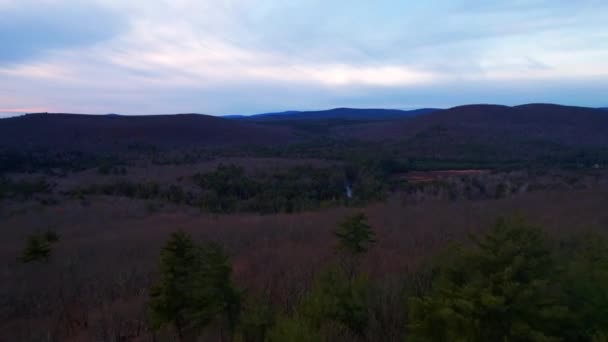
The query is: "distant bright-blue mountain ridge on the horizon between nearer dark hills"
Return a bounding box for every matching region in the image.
[237,108,438,122]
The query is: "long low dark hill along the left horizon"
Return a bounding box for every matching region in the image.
[0,114,295,150]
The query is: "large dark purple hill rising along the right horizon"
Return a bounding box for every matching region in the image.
[336,104,608,146]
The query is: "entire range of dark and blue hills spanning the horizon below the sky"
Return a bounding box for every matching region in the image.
[0,104,608,150]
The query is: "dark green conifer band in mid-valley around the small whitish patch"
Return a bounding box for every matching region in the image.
[68,164,389,214]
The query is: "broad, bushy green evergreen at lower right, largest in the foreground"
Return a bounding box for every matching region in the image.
[409,220,569,342]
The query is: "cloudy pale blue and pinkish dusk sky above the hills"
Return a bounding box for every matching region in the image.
[0,0,608,116]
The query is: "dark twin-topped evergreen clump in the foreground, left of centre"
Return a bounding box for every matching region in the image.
[149,232,240,341]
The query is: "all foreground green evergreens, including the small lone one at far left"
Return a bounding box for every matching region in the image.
[13,213,608,342]
